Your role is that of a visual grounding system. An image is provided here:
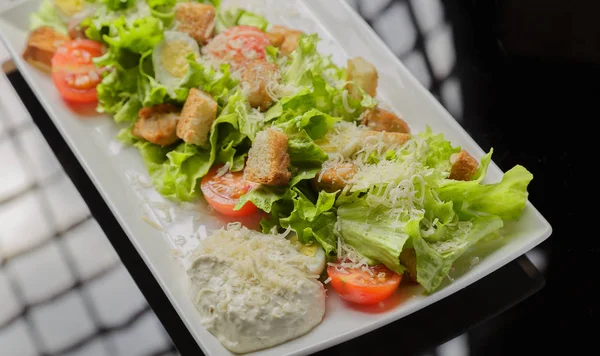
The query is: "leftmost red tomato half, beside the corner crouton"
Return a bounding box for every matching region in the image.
[52,39,103,103]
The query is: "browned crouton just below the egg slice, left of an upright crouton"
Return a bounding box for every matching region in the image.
[131,104,179,146]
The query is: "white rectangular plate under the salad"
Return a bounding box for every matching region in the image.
[0,0,552,356]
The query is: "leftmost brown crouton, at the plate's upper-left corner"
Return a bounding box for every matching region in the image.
[23,26,69,72]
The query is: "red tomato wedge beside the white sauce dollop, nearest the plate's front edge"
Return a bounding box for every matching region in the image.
[327,264,402,305]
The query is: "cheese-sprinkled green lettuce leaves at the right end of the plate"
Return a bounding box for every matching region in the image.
[336,128,533,292]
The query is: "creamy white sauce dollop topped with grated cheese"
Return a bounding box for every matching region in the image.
[188,224,325,353]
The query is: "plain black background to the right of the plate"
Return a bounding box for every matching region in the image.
[444,0,600,355]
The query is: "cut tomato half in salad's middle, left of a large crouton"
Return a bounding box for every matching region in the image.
[200,166,258,217]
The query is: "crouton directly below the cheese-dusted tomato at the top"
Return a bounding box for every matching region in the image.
[241,59,279,111]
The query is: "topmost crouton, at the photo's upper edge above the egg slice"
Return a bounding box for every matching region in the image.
[175,2,216,45]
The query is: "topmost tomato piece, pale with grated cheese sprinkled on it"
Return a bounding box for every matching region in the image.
[205,26,270,66]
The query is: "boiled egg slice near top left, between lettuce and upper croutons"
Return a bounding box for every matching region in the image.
[152,31,200,91]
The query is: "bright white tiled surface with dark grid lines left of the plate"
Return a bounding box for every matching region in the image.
[0,35,177,356]
